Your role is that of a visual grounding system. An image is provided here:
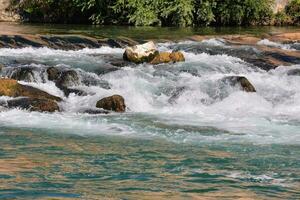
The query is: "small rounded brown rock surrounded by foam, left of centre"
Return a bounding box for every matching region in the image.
[96,95,126,112]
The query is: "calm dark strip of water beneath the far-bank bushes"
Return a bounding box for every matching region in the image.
[0,22,300,40]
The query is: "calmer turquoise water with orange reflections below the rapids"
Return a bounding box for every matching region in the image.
[0,124,300,199]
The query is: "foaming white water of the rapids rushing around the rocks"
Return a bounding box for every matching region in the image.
[0,40,300,144]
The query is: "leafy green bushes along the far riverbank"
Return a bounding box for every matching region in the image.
[10,0,300,27]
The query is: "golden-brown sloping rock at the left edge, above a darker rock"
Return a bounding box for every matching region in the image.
[0,79,62,101]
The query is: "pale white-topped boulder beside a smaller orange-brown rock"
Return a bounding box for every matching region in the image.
[123,41,158,63]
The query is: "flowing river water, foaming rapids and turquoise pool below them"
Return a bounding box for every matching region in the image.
[0,28,300,199]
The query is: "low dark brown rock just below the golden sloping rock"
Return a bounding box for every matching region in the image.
[7,98,59,112]
